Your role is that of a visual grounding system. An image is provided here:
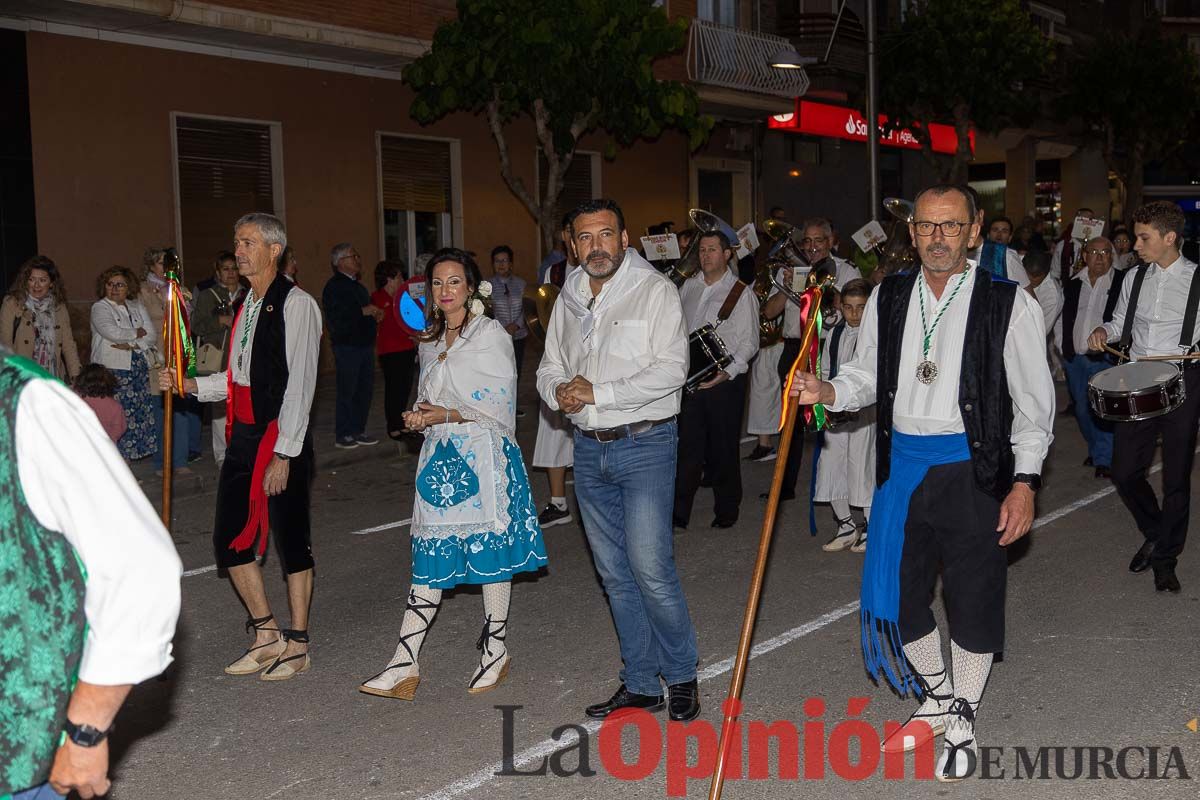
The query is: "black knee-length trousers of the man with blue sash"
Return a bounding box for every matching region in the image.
[899,461,1008,652]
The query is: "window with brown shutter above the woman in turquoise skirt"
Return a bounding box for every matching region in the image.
[379,134,458,269]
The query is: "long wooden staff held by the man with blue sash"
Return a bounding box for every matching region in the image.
[708,282,828,800]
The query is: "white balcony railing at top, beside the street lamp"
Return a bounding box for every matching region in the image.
[688,19,809,97]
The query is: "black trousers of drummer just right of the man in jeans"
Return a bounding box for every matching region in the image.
[674,373,746,525]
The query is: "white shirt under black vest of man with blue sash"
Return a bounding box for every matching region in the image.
[829,263,1055,473]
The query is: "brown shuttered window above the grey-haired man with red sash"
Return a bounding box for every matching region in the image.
[174,115,283,262]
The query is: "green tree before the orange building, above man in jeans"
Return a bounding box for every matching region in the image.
[404,0,713,248]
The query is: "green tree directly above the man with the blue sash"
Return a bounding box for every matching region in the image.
[880,0,1051,182]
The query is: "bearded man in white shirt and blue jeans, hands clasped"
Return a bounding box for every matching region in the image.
[538,199,700,720]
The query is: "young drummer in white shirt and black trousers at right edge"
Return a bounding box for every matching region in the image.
[1088,200,1200,593]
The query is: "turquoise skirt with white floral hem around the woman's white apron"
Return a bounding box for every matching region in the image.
[413,437,546,589]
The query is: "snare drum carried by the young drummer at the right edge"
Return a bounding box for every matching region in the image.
[1087,361,1186,422]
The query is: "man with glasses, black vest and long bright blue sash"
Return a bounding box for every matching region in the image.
[793,186,1054,781]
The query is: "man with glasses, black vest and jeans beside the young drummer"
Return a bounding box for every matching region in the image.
[1062,236,1124,477]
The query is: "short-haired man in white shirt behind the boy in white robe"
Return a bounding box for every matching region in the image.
[760,217,863,500]
